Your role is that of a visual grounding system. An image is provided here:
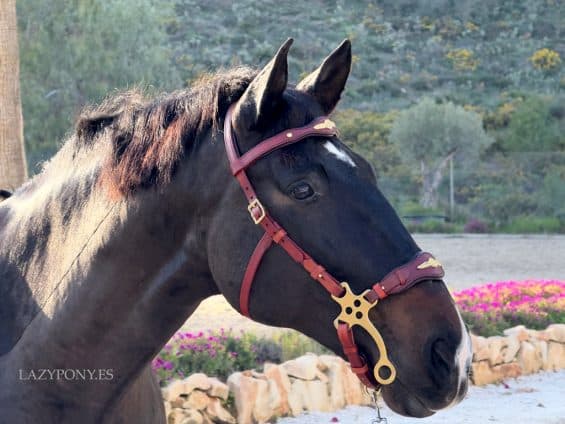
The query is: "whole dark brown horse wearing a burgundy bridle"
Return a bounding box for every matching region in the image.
[0,39,471,424]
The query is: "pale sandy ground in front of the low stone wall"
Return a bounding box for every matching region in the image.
[277,371,565,424]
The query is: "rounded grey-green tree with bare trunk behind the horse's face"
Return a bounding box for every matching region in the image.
[390,98,493,208]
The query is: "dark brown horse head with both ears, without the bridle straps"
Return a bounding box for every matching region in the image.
[207,41,471,417]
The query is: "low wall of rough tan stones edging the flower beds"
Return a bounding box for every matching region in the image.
[163,324,565,424]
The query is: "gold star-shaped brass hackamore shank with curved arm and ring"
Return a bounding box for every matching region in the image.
[332,282,396,385]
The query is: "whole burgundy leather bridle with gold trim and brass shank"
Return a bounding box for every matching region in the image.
[224,105,444,388]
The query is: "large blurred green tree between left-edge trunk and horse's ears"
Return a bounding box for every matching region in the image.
[19,0,178,171]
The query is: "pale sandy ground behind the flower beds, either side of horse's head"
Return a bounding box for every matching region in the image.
[184,234,565,336]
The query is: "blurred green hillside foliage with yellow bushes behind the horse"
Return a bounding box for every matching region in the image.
[17,0,565,232]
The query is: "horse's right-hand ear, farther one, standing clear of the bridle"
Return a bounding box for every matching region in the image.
[296,40,351,114]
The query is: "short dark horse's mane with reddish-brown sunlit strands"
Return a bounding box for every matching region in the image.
[73,67,257,196]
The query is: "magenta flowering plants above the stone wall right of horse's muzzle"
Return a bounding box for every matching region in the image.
[453,280,565,336]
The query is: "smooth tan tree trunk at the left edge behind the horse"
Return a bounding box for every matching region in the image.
[0,0,27,189]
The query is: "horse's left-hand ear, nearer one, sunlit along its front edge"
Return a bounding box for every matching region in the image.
[231,38,293,130]
